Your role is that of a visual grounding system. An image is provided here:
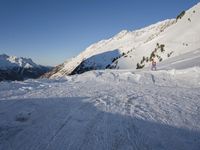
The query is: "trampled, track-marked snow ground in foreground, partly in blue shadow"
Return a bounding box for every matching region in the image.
[0,67,200,150]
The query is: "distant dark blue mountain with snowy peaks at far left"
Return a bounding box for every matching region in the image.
[0,54,51,81]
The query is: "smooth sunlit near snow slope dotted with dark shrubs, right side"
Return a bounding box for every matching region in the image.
[117,3,200,68]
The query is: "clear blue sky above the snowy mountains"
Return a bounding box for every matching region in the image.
[0,0,199,65]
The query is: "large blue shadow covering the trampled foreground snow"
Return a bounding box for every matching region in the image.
[0,97,200,150]
